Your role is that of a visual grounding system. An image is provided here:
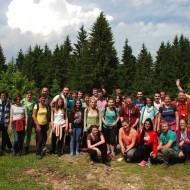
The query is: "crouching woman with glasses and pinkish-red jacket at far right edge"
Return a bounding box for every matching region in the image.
[176,118,190,164]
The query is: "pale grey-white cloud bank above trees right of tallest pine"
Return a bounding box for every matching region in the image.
[113,21,189,57]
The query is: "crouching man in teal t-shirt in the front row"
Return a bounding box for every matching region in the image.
[157,121,179,168]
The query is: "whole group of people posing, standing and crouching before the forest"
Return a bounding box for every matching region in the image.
[0,81,190,167]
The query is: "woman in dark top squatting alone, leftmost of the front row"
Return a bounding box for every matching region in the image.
[87,125,110,166]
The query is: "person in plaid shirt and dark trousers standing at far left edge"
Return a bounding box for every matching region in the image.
[0,91,12,155]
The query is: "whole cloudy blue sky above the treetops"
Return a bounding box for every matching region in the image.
[0,0,190,62]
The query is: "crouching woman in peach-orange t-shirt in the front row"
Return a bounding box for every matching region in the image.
[119,120,137,162]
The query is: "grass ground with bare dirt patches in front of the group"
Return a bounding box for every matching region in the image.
[0,132,190,190]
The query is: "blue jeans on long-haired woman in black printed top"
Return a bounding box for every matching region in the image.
[70,128,82,152]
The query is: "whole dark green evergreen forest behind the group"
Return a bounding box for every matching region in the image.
[0,12,190,98]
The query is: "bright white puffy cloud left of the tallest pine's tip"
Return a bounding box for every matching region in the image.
[6,0,112,36]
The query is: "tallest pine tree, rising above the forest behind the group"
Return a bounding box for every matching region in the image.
[89,12,119,93]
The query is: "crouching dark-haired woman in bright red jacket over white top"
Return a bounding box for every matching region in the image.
[134,118,158,166]
